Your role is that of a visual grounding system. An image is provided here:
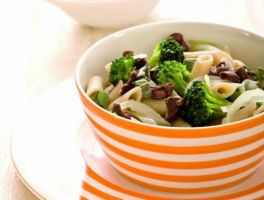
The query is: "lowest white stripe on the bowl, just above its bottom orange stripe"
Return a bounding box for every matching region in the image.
[108,162,262,189]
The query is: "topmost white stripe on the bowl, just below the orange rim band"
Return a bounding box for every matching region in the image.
[84,107,264,147]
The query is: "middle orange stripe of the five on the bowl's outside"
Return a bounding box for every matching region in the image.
[96,135,264,169]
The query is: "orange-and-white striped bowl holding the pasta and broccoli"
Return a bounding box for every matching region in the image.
[76,22,264,193]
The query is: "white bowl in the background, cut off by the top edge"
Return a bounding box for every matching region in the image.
[48,0,159,28]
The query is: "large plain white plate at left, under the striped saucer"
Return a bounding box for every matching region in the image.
[10,79,86,200]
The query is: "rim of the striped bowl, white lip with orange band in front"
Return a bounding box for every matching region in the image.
[75,20,264,131]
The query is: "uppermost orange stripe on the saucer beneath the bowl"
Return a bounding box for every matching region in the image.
[86,167,264,200]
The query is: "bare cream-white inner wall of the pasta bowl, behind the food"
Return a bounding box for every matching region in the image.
[76,22,264,92]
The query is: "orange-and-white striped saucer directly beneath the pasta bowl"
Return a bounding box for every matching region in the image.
[81,124,264,200]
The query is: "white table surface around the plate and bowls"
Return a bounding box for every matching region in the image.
[0,0,264,200]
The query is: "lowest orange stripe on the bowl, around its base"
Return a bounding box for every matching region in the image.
[119,172,254,194]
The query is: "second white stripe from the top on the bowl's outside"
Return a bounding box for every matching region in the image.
[92,125,264,162]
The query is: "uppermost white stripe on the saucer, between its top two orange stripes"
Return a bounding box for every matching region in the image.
[84,173,141,200]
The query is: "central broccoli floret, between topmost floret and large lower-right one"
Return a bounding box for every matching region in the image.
[155,61,190,96]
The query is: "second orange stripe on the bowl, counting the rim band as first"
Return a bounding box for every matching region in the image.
[89,117,264,154]
